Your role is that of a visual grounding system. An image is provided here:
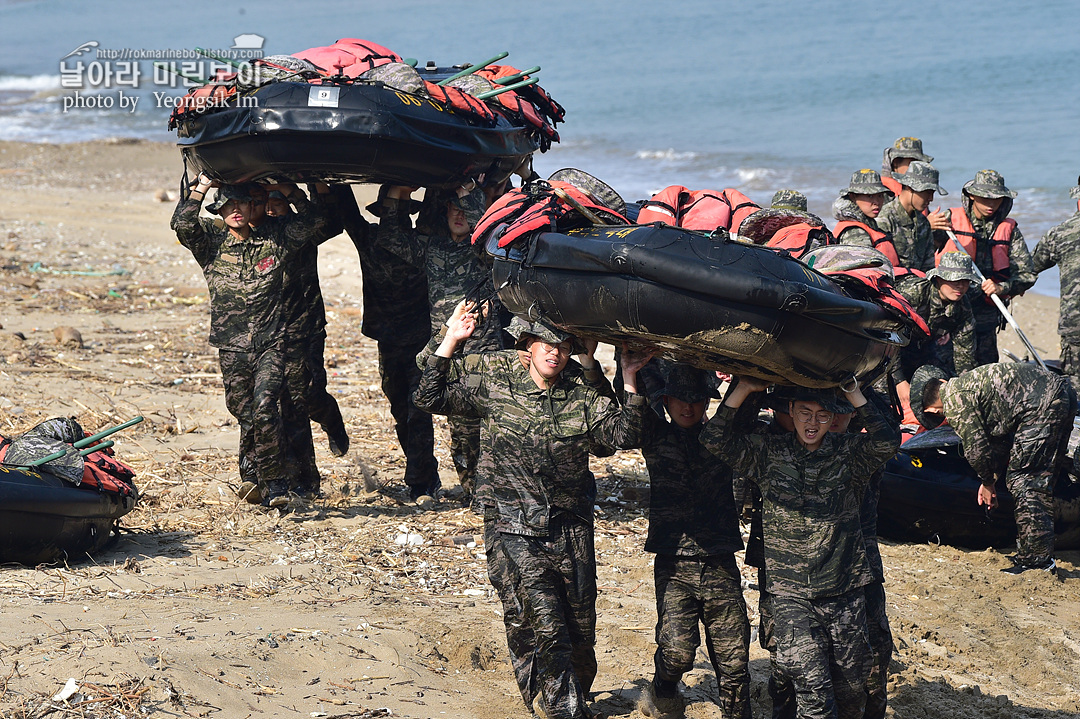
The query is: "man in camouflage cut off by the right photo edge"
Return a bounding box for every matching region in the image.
[1031,177,1080,393]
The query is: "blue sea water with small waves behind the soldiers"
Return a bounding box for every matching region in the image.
[0,0,1080,294]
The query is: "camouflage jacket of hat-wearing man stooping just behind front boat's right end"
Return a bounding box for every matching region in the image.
[892,274,975,382]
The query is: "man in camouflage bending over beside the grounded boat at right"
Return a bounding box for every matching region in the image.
[912,362,1077,573]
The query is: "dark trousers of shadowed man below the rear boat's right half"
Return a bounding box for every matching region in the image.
[379,340,438,487]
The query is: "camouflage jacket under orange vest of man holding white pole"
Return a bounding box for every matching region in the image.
[934,195,1038,331]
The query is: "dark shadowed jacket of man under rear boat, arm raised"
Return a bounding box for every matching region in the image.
[335,187,431,347]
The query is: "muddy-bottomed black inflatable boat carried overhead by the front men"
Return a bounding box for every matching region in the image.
[485,226,907,386]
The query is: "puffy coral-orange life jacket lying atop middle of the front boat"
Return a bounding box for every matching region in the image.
[637,185,761,234]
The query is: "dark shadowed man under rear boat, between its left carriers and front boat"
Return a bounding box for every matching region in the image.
[335,184,442,500]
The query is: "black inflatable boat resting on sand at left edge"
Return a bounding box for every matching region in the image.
[0,465,136,565]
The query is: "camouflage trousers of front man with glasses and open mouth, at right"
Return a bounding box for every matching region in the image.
[772,587,874,719]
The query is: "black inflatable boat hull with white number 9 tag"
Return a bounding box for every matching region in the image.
[176,73,540,187]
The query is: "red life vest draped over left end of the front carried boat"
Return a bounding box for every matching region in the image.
[472,181,630,247]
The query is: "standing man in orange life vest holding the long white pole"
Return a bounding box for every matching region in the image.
[934,169,1037,365]
